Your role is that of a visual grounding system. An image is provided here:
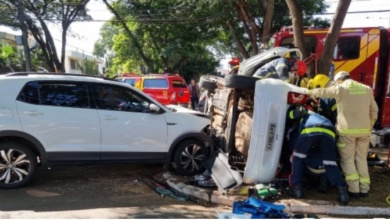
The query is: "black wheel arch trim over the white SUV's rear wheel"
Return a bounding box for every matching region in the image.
[0,130,47,165]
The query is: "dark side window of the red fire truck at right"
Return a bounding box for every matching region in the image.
[333,37,360,60]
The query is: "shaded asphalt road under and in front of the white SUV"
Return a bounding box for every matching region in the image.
[0,164,231,219]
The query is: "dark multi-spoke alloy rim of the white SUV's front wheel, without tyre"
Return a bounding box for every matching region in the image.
[180,144,205,172]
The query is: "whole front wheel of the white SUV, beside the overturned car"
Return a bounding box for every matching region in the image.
[172,139,210,176]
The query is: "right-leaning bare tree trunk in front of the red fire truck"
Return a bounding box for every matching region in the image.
[318,0,351,75]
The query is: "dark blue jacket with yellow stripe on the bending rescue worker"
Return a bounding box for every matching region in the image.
[288,108,336,140]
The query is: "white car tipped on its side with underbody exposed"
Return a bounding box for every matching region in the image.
[199,48,308,184]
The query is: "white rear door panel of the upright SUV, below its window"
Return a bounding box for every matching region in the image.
[16,101,100,152]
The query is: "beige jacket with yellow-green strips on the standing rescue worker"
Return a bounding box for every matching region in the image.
[307,79,378,136]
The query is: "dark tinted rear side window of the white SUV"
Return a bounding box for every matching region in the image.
[18,81,90,108]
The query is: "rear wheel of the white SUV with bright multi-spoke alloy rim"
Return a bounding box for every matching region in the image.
[0,142,37,189]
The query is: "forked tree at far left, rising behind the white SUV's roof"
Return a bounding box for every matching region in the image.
[0,0,90,71]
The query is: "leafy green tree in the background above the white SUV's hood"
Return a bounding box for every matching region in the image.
[99,0,218,76]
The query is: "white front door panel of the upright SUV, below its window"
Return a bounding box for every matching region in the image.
[98,110,167,152]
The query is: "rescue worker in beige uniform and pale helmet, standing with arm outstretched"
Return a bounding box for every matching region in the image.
[307,71,378,198]
